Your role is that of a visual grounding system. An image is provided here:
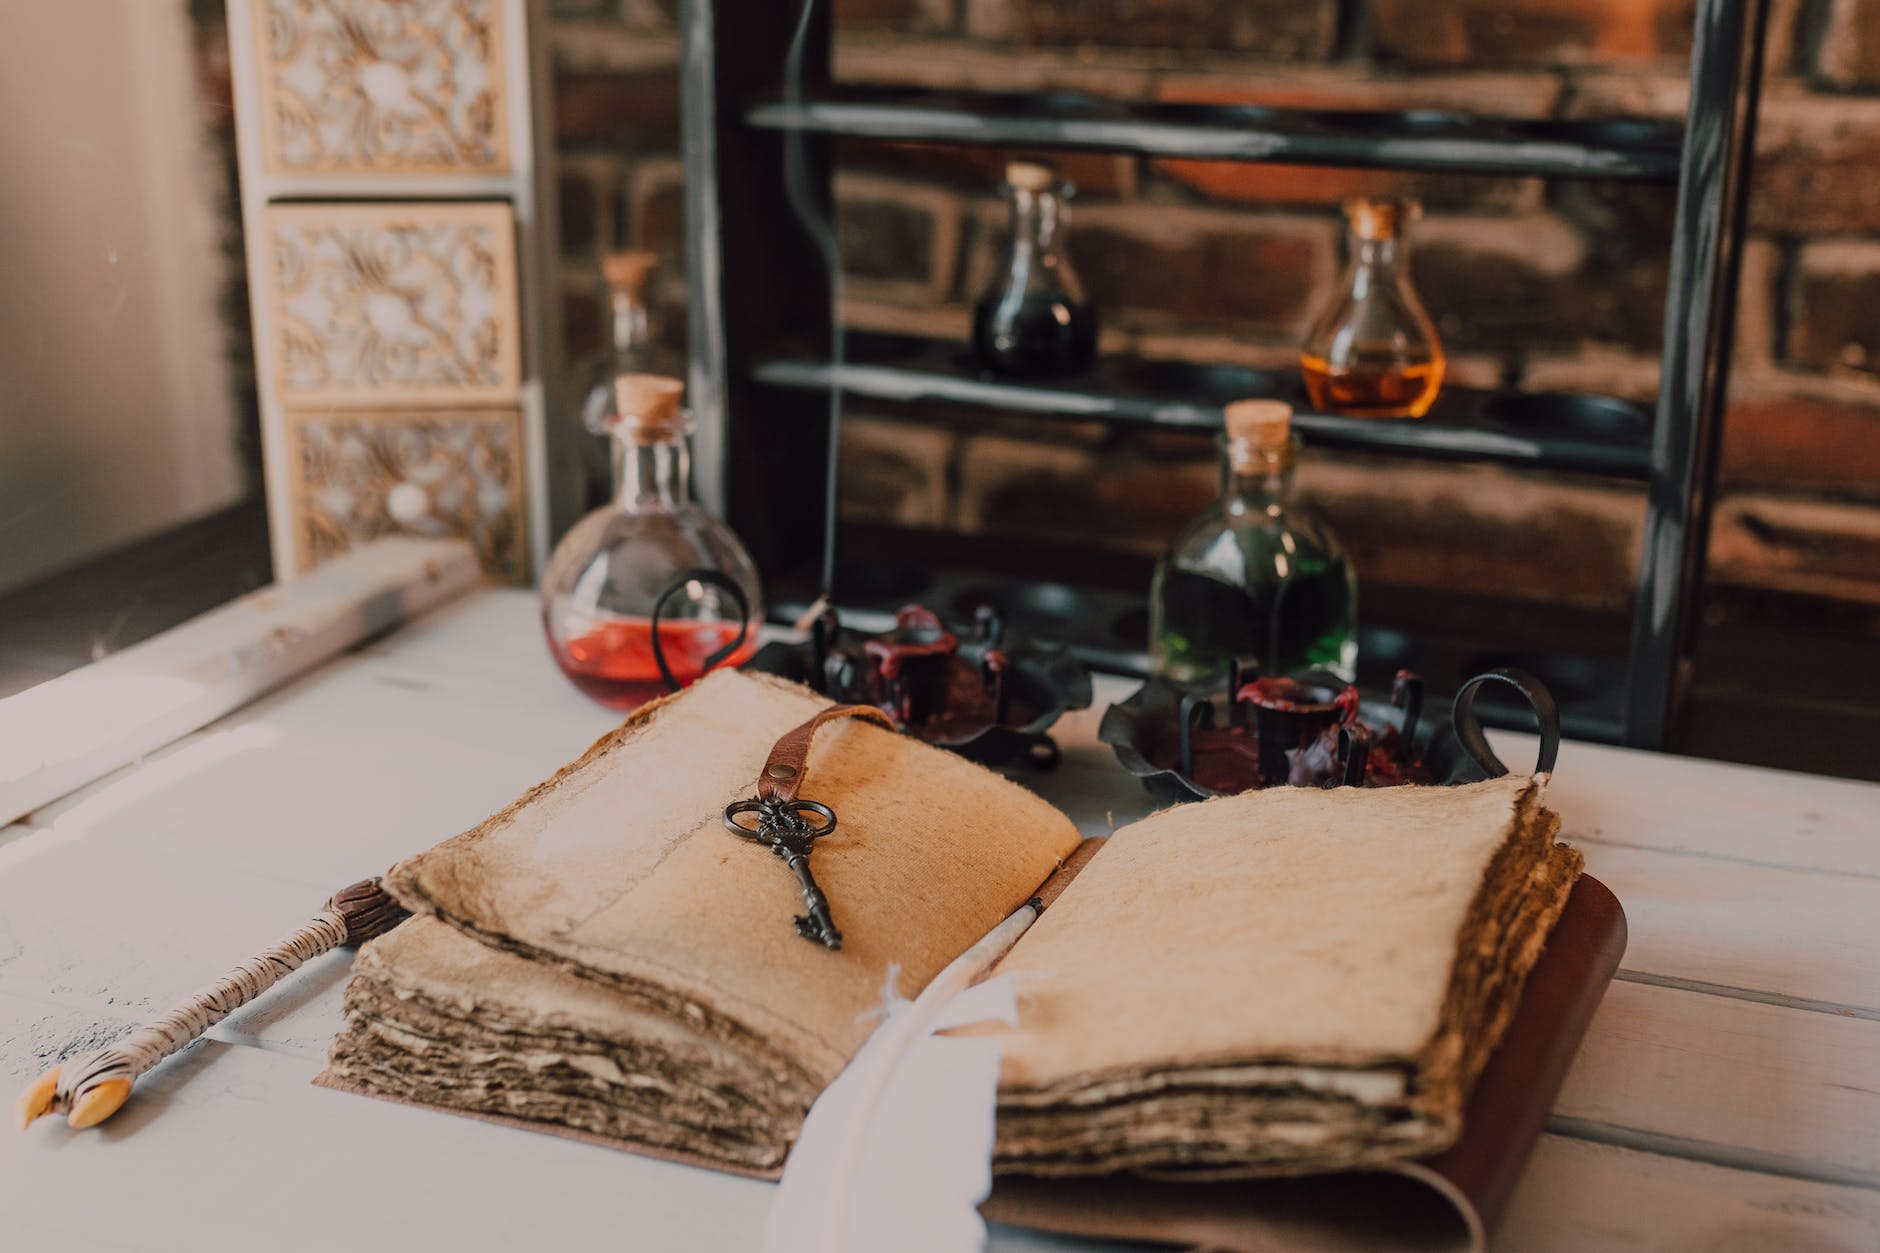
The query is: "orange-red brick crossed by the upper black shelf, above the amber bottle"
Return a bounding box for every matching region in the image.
[1154,73,1559,211]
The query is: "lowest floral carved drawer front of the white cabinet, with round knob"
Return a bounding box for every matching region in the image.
[288,408,528,583]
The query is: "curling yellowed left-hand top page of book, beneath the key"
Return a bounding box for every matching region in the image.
[387,672,1077,1091]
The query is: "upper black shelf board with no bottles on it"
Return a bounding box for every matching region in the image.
[744,87,1683,182]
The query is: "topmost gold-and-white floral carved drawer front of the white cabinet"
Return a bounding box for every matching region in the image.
[250,0,509,175]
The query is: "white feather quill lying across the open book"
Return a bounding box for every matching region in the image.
[763,905,1038,1253]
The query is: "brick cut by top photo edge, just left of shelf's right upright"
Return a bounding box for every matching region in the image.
[1371,0,1696,68]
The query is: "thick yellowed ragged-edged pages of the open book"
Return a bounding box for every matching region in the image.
[323,672,1579,1176]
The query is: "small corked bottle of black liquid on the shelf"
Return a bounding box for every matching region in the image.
[972,162,1096,378]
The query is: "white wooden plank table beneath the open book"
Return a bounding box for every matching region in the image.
[0,591,1880,1253]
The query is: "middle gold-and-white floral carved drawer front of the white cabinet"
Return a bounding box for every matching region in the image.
[263,203,521,404]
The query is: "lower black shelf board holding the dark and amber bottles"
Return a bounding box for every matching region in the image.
[754,335,1651,480]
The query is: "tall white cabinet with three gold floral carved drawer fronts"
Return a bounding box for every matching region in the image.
[229,0,555,581]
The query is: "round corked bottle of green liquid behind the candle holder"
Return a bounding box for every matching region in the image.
[1149,401,1357,685]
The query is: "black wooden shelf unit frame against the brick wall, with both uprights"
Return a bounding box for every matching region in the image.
[681,0,1769,747]
